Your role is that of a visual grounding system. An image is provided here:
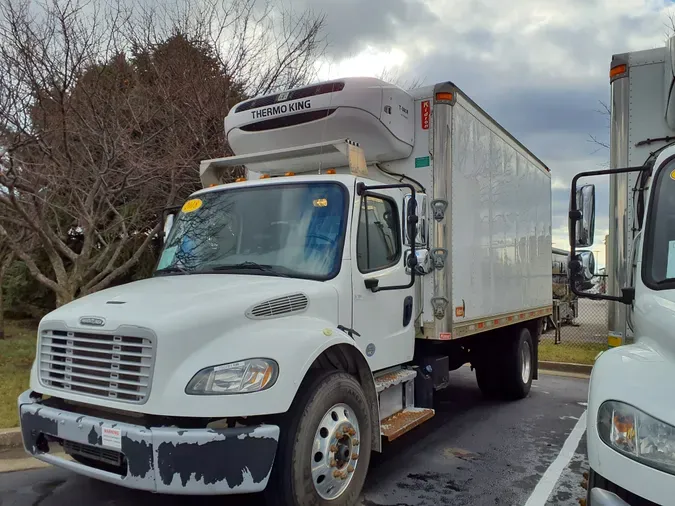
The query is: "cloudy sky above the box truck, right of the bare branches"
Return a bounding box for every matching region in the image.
[304,0,675,266]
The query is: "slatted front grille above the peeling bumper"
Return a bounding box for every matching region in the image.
[38,330,154,403]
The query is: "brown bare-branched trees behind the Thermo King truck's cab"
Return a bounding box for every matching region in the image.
[0,0,323,305]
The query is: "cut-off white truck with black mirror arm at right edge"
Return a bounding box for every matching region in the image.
[570,38,675,506]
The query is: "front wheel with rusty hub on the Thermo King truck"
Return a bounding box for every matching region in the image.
[265,372,371,506]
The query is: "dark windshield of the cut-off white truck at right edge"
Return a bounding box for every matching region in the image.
[643,162,675,289]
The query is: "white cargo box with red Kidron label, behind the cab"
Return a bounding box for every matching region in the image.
[383,83,552,339]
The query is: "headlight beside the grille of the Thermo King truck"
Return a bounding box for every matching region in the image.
[185,358,279,395]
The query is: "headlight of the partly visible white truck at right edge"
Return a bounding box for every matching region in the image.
[598,401,675,474]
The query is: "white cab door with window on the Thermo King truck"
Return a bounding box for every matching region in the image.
[351,181,415,370]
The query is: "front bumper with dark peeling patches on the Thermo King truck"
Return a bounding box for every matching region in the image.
[18,391,279,494]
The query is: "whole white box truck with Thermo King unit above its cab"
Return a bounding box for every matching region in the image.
[18,78,552,505]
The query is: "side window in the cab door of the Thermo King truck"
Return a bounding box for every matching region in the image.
[356,195,401,272]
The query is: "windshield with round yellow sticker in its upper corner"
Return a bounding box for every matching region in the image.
[156,182,347,279]
